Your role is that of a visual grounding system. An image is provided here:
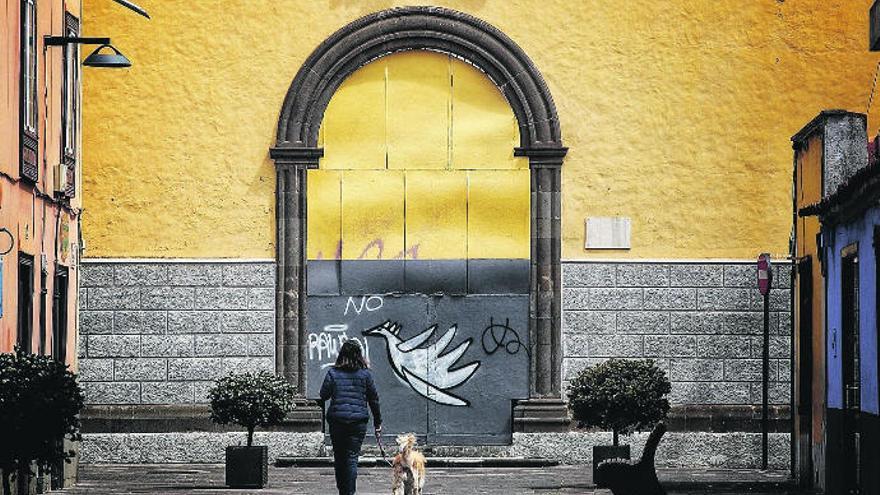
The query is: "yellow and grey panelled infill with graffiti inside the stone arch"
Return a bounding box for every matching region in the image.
[305,50,530,444]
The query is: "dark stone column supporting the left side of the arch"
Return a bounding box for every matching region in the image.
[270,147,324,430]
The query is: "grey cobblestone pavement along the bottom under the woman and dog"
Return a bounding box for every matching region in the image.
[52,464,795,495]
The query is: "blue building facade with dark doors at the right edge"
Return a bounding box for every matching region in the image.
[798,131,880,495]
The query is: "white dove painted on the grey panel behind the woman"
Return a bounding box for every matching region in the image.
[363,320,480,407]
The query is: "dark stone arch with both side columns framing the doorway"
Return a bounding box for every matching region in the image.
[270,7,567,431]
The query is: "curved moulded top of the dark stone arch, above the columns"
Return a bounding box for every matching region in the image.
[276,7,562,148]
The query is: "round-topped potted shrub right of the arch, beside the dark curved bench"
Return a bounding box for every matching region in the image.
[568,359,672,487]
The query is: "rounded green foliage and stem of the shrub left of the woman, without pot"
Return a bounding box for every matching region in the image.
[208,371,294,447]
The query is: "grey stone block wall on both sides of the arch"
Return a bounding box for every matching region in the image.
[79,260,791,405]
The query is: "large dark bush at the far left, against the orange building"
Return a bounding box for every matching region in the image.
[0,348,83,495]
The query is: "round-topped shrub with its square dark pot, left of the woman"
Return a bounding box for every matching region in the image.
[208,371,294,488]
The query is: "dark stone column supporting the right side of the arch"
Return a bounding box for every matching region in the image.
[513,146,568,432]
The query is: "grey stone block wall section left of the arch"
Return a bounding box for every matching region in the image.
[79,260,275,404]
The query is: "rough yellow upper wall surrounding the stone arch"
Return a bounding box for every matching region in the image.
[84,0,880,258]
